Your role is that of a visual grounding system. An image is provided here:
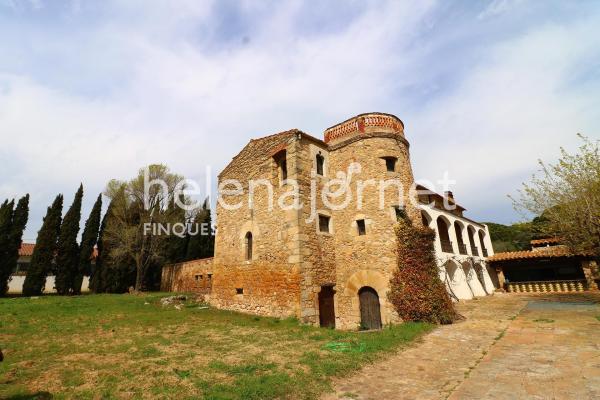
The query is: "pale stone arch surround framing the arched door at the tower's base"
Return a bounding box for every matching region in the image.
[343,269,398,327]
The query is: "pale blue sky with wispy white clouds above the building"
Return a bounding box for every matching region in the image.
[0,0,600,241]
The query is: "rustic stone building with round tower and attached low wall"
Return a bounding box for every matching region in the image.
[162,113,492,329]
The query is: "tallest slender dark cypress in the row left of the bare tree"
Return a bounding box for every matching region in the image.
[54,185,83,295]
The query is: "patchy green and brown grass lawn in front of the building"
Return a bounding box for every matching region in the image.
[0,293,432,400]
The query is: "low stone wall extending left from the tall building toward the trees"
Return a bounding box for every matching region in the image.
[160,258,213,295]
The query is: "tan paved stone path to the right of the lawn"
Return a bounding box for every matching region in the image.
[325,293,600,400]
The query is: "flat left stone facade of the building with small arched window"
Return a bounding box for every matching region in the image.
[211,131,300,317]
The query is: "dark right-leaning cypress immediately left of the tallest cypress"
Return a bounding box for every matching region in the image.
[23,194,63,296]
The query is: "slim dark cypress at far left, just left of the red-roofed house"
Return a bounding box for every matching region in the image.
[0,194,29,296]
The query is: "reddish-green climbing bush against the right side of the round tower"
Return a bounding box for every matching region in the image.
[388,219,459,324]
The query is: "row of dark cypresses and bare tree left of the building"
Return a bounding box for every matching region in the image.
[0,165,214,296]
